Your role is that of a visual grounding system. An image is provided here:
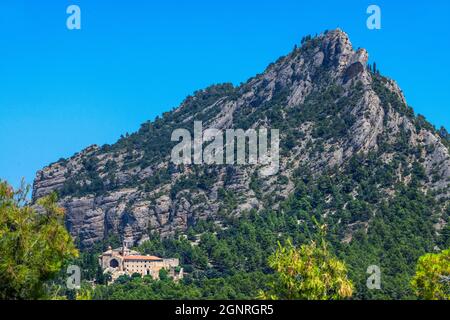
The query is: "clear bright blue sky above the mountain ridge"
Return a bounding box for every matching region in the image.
[0,0,450,189]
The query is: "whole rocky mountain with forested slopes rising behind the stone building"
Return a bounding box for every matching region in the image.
[33,30,450,298]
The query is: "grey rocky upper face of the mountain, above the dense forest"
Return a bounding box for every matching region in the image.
[33,30,450,246]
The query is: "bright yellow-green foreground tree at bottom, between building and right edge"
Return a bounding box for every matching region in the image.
[259,229,353,300]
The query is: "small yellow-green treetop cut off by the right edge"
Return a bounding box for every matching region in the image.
[411,249,450,300]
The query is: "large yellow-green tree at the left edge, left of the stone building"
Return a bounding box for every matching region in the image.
[0,182,78,300]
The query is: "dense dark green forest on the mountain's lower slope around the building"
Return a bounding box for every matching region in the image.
[67,161,448,299]
